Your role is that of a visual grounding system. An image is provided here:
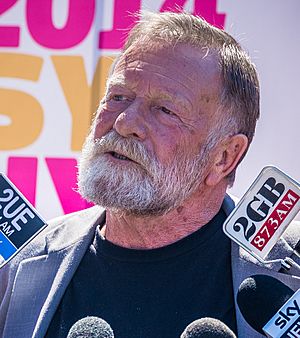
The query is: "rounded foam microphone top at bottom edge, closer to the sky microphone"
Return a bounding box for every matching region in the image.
[180,317,236,338]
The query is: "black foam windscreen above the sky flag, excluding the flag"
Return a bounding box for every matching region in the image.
[237,275,294,334]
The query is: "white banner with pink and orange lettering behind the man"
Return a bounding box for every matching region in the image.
[0,0,300,219]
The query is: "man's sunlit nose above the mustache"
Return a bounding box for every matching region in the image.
[114,99,147,140]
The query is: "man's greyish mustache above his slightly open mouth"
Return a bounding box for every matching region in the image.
[89,130,157,170]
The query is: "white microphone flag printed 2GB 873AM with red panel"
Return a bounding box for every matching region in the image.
[223,166,300,261]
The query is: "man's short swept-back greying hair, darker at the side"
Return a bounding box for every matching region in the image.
[123,12,259,184]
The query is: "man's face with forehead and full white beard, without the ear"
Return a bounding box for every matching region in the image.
[79,44,220,215]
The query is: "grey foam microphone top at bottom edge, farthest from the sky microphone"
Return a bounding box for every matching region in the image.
[67,316,114,338]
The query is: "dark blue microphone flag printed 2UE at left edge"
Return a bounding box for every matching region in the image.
[0,173,46,268]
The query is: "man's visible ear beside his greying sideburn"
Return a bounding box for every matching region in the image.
[205,134,248,186]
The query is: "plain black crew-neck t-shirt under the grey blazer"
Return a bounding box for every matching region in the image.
[46,211,236,338]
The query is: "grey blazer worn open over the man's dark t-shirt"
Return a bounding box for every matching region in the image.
[0,196,300,338]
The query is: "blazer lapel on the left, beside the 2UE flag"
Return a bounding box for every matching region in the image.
[4,208,105,338]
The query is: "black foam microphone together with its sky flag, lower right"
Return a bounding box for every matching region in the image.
[237,275,300,337]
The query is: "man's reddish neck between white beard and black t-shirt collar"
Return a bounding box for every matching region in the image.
[103,187,226,249]
